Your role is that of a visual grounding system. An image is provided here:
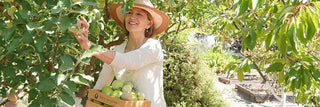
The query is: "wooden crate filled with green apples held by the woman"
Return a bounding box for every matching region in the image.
[86,80,151,107]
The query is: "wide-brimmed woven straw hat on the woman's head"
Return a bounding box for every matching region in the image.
[109,0,169,35]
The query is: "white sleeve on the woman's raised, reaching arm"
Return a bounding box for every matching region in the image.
[110,40,163,70]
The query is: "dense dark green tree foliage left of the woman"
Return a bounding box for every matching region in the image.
[0,0,119,107]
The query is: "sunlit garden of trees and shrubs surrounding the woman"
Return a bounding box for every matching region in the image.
[0,0,320,107]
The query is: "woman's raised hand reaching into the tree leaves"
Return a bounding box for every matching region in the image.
[73,17,91,50]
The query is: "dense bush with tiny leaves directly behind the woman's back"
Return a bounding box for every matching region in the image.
[163,33,225,107]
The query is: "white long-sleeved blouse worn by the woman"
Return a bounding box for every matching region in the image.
[94,38,166,107]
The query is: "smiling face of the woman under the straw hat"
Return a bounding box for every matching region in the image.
[125,8,152,32]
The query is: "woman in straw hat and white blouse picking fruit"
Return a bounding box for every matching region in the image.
[75,0,169,107]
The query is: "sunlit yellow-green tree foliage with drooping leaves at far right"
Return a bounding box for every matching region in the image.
[212,0,320,104]
